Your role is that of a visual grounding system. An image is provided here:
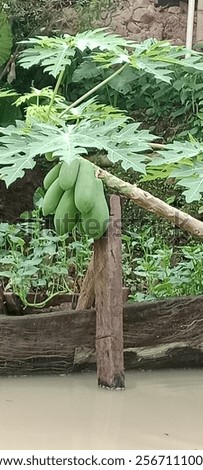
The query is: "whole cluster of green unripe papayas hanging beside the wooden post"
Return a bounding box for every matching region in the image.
[42,158,109,240]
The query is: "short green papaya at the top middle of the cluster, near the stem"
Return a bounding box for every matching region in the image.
[59,158,80,191]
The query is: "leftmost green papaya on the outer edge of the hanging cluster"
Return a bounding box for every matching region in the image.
[42,178,64,216]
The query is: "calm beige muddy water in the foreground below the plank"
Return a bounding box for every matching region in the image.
[0,370,203,450]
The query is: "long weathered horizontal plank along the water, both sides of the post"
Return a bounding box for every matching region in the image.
[0,296,203,376]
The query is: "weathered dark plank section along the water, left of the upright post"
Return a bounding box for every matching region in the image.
[0,310,95,375]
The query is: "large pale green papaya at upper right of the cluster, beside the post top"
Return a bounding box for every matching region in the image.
[75,158,96,214]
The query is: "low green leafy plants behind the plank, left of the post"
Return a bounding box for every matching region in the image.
[0,199,92,307]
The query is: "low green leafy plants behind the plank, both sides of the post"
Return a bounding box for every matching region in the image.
[0,207,203,308]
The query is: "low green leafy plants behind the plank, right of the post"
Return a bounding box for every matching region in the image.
[123,226,203,301]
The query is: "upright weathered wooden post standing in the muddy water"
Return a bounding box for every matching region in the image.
[94,195,125,389]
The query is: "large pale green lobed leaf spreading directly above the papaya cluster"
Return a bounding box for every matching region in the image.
[0,116,155,186]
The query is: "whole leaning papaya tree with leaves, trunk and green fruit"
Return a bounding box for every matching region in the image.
[0,29,203,238]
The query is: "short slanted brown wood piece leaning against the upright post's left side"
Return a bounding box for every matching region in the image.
[77,254,95,310]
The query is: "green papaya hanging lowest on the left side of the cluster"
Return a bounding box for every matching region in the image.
[54,188,79,235]
